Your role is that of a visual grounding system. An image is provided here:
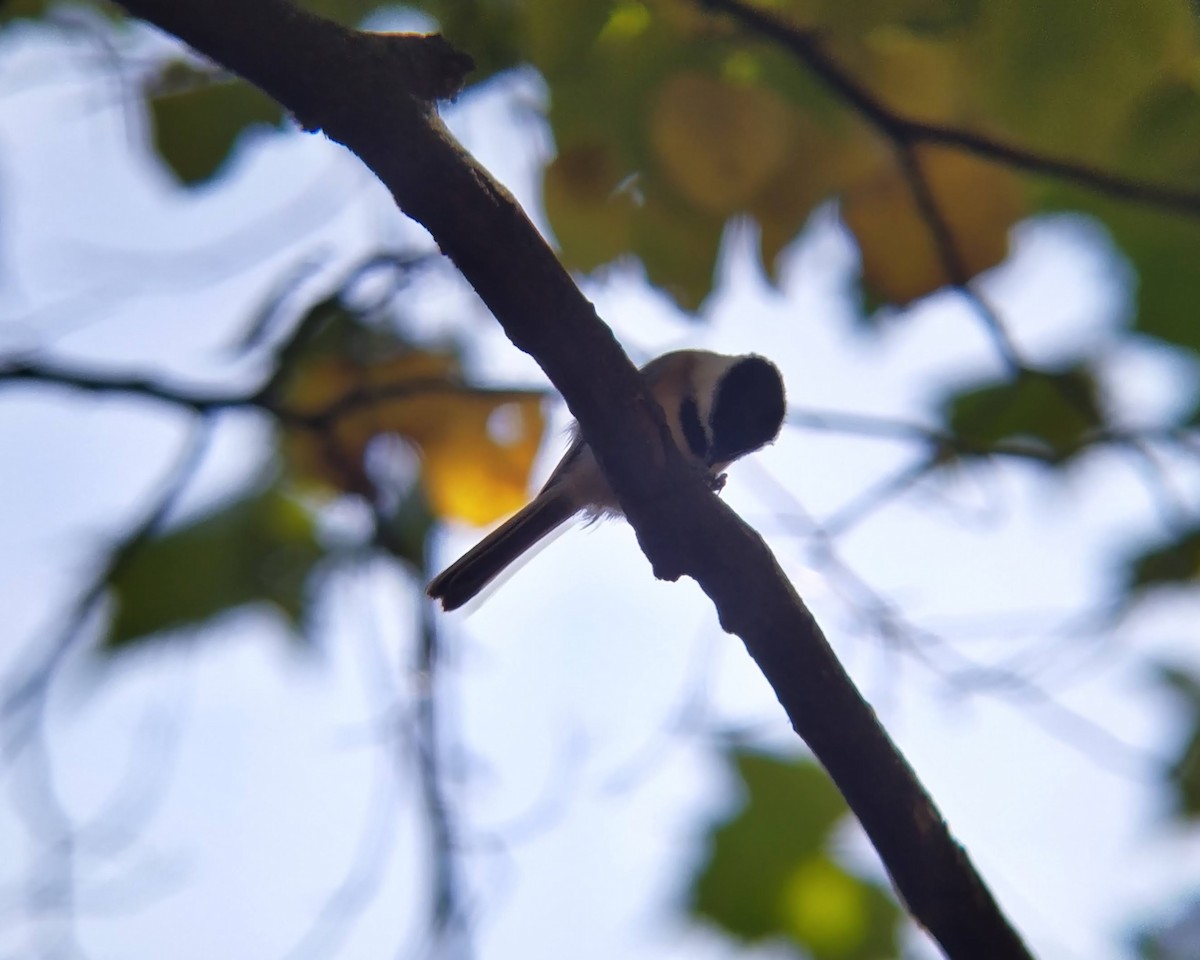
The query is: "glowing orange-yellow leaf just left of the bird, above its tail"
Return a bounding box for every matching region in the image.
[283,350,545,524]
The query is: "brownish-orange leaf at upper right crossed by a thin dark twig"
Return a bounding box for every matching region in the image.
[841,148,1026,304]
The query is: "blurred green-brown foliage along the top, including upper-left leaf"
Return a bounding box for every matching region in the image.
[18,0,1200,349]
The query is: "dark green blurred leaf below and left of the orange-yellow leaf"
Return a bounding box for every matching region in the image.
[103,487,324,650]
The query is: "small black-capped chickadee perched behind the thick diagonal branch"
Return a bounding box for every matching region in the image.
[426,350,785,610]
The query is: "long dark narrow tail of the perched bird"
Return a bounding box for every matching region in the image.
[425,493,576,610]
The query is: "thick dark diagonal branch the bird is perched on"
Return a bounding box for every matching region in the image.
[112,0,1030,960]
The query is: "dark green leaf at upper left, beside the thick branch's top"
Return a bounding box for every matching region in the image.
[149,61,283,186]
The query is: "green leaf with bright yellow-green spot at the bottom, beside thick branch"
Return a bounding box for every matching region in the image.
[691,751,902,960]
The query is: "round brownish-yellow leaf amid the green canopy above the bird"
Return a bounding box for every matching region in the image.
[649,72,796,215]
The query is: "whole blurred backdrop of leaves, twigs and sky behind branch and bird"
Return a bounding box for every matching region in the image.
[0,0,1200,960]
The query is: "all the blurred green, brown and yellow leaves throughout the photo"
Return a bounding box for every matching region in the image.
[0,0,1200,960]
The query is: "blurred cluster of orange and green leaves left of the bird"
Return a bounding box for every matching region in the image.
[104,258,545,650]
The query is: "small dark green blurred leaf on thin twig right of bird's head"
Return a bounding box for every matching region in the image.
[944,365,1104,463]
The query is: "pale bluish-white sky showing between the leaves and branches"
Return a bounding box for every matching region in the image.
[0,11,1200,960]
